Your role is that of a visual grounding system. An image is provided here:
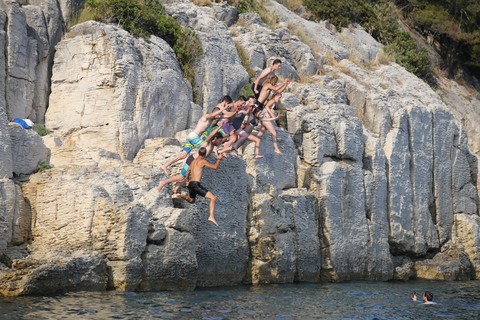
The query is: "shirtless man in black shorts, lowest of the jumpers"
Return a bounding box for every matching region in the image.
[172,148,222,227]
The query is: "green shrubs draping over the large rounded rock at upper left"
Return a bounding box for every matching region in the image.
[85,0,203,100]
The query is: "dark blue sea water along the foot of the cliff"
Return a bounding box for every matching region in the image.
[0,281,480,320]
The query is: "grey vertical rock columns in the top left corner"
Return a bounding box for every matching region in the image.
[0,0,63,123]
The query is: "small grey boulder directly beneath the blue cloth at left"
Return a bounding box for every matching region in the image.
[9,123,50,174]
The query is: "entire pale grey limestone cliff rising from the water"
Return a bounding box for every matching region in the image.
[0,0,480,295]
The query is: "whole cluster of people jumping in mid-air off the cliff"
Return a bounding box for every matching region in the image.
[158,59,292,226]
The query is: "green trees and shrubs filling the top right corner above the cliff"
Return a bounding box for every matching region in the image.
[303,0,480,81]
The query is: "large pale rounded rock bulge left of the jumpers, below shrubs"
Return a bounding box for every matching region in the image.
[46,22,192,160]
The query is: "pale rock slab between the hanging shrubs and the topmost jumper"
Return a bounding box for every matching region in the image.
[166,1,248,111]
